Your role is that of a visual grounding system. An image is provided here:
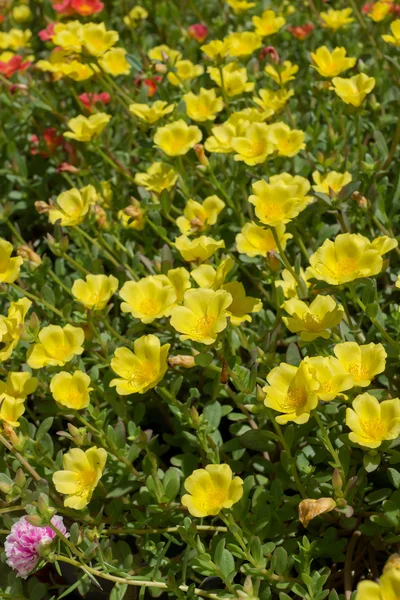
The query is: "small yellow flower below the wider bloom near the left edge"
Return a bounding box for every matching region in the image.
[50,371,93,410]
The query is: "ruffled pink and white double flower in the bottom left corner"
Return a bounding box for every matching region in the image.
[4,515,69,579]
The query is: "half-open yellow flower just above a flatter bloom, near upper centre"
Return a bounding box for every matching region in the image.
[176,196,225,235]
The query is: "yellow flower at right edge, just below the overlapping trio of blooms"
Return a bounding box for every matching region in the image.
[346,394,400,448]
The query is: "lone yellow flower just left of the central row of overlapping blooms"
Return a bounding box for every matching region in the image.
[71,275,118,310]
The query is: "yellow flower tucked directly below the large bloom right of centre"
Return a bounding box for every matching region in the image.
[236,223,293,258]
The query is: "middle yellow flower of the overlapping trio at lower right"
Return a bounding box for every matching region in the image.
[304,356,353,402]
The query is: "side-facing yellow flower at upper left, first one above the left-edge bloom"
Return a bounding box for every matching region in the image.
[49,185,97,227]
